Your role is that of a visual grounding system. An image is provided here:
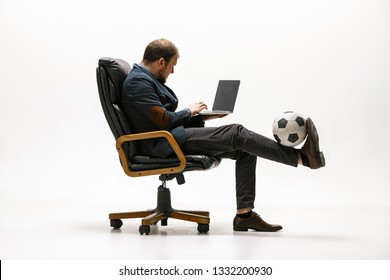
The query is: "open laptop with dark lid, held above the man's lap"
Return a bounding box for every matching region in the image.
[199,80,240,116]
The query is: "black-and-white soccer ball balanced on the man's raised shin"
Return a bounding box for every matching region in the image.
[272,111,306,147]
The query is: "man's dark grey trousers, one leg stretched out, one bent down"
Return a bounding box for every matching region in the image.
[182,124,299,209]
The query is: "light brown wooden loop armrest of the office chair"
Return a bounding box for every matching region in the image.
[116,130,186,177]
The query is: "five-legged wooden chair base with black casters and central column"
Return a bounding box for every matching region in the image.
[109,186,210,234]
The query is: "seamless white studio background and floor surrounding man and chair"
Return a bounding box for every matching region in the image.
[0,0,390,266]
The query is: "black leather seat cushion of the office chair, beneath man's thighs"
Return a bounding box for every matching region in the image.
[130,155,221,171]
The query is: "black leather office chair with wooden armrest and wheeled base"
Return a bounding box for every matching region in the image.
[96,57,220,234]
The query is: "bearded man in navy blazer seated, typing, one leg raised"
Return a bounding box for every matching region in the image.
[121,39,325,232]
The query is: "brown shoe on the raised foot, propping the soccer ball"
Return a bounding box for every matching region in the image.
[301,118,325,169]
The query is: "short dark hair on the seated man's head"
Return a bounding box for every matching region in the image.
[143,39,179,63]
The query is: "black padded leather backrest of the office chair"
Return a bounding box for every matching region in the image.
[96,57,137,155]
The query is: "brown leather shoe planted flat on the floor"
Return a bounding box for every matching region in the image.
[233,212,282,232]
